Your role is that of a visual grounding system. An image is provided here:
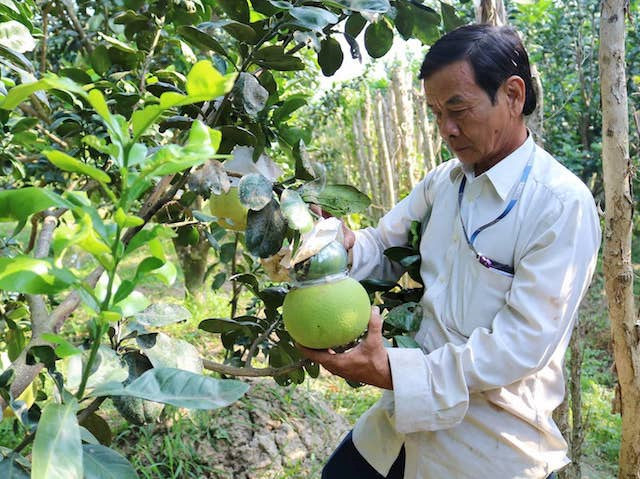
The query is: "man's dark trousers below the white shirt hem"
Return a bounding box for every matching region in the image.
[322,432,556,479]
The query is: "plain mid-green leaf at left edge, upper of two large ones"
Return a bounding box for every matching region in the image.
[0,186,72,222]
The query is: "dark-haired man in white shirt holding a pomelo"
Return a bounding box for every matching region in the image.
[303,25,600,479]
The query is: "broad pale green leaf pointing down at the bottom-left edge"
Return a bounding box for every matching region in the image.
[31,401,83,479]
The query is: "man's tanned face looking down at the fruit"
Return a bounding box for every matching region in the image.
[424,61,526,174]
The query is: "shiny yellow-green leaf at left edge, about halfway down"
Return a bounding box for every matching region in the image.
[0,256,76,294]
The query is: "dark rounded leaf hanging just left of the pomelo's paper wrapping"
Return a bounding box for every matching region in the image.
[245,200,287,258]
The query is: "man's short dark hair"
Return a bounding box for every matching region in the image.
[419,24,536,115]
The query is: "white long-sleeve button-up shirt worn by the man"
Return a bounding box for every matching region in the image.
[351,135,601,479]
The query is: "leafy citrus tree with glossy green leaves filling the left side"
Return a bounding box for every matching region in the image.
[0,0,459,479]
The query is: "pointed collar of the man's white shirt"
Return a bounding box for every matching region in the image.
[449,132,534,201]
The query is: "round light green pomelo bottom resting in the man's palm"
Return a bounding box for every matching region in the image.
[282,278,371,349]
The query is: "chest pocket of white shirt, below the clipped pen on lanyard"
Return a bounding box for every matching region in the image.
[456,248,513,337]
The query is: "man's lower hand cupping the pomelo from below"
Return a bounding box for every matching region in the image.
[297,306,393,389]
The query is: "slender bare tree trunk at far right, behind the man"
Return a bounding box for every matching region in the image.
[599,0,640,479]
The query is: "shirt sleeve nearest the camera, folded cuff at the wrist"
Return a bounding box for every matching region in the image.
[388,188,601,433]
